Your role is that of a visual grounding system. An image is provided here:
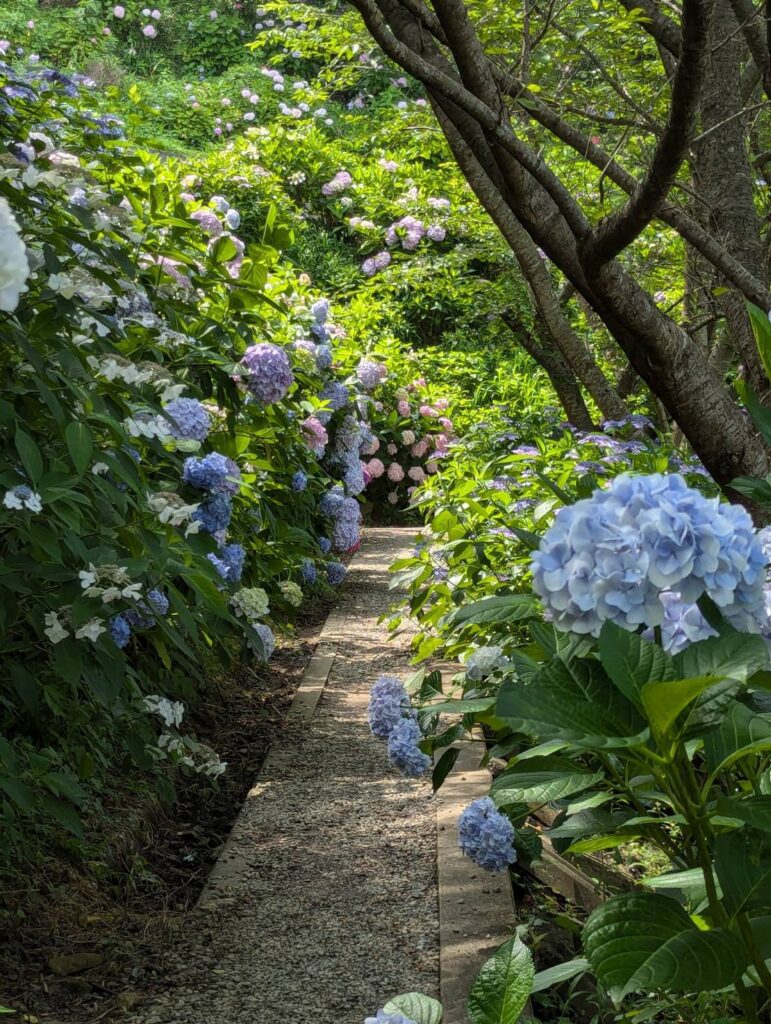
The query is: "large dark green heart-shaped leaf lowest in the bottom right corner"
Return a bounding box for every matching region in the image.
[584,893,746,1002]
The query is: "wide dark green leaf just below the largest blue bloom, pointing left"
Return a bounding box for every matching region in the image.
[496,657,647,749]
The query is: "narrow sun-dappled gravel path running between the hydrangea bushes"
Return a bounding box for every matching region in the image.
[129,528,439,1024]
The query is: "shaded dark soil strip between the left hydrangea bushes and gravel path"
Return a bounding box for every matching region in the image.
[0,601,332,1024]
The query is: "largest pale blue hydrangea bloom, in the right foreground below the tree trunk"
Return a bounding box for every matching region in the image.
[532,473,767,636]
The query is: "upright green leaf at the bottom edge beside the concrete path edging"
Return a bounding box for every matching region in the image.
[468,936,536,1024]
